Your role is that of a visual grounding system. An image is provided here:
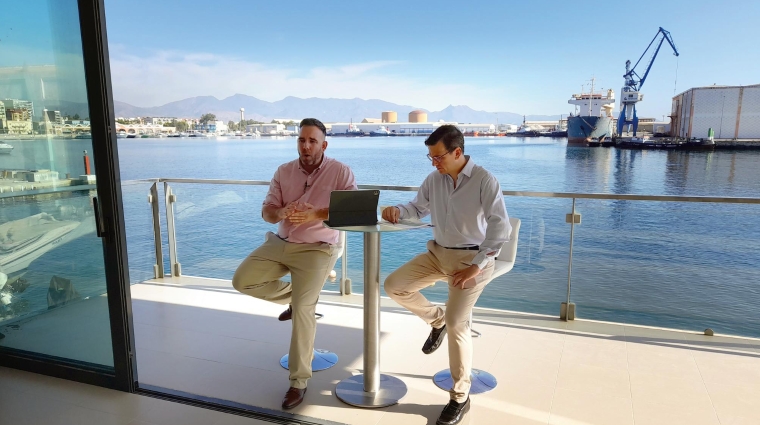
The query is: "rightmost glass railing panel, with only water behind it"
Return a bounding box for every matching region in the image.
[572,199,760,337]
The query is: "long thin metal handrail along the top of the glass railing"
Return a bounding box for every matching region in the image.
[129,178,760,204]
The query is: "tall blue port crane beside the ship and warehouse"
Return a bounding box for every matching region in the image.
[617,27,679,136]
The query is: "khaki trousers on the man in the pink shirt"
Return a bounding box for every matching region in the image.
[232,232,339,388]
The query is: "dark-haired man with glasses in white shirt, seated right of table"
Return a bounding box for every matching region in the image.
[382,125,512,425]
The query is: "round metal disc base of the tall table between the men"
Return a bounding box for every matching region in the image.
[335,374,407,407]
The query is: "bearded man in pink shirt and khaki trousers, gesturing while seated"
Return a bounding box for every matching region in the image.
[232,118,356,409]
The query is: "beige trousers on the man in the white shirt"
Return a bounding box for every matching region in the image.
[385,241,494,403]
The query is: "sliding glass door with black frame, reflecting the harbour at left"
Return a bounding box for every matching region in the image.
[0,0,133,387]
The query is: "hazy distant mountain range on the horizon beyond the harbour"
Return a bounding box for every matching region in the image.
[114,94,560,124]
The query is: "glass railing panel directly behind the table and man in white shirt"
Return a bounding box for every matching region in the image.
[348,190,571,315]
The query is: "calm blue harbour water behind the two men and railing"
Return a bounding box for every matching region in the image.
[0,138,760,336]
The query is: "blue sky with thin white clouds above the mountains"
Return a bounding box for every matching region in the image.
[7,0,760,118]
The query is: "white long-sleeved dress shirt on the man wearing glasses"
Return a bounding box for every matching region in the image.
[397,155,512,269]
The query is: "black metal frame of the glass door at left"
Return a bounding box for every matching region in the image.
[0,0,137,392]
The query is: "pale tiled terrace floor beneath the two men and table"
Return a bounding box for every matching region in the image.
[0,277,760,425]
